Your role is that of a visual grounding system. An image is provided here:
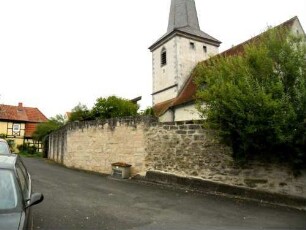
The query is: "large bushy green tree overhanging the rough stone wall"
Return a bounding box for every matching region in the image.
[195,28,306,167]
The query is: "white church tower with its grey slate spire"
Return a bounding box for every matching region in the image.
[149,0,221,106]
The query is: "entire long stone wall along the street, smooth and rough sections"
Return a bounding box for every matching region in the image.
[49,119,306,198]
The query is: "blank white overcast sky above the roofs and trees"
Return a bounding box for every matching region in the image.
[0,0,306,117]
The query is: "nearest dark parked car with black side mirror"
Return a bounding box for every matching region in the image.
[0,154,44,230]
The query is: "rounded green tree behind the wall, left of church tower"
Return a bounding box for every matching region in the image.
[92,96,138,119]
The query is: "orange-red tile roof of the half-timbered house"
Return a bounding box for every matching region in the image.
[0,103,48,123]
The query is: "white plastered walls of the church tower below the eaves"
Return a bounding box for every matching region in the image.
[152,36,219,105]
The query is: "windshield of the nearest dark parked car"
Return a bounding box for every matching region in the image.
[0,170,18,211]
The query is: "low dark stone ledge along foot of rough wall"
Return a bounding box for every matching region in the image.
[134,171,306,210]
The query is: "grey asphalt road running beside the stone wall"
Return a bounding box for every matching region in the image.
[24,158,306,230]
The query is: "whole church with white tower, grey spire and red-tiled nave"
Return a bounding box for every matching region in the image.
[149,0,305,122]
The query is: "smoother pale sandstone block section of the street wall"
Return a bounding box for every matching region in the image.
[49,119,152,174]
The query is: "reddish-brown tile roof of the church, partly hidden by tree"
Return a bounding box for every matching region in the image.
[153,17,298,116]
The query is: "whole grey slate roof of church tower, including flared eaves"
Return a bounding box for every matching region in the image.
[149,0,221,51]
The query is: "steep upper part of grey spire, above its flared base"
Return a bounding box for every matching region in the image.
[167,0,200,33]
